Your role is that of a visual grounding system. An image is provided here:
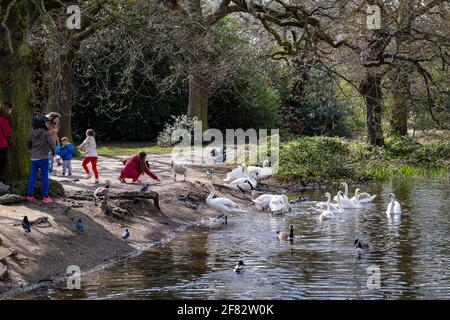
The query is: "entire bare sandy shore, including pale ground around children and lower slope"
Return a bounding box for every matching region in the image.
[0,154,251,297]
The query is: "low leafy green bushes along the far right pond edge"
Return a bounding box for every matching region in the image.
[268,136,450,185]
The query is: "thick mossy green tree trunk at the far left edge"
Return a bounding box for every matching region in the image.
[0,0,38,184]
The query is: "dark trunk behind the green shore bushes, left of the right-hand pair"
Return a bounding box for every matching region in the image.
[360,71,384,146]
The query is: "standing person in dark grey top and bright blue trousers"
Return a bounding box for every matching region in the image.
[26,115,56,202]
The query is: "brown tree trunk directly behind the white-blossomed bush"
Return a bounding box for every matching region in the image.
[187,76,209,131]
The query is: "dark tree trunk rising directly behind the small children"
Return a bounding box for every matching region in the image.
[47,47,77,141]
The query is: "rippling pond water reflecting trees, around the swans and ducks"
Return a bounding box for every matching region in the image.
[17,179,450,299]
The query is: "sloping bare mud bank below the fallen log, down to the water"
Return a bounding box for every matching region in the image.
[0,182,225,297]
